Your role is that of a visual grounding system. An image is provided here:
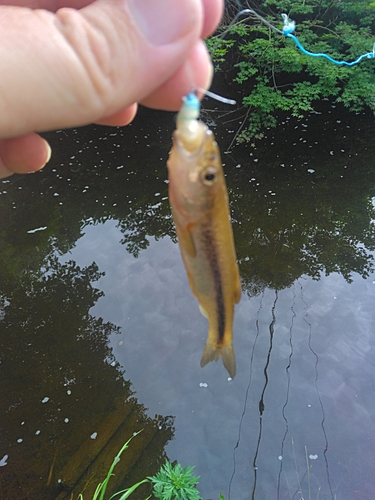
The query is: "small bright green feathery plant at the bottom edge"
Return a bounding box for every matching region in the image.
[148,461,201,500]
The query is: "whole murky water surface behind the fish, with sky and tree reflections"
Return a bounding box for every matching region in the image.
[0,94,375,500]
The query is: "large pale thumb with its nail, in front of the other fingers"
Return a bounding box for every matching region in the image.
[0,0,208,137]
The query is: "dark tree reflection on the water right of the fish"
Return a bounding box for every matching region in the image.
[226,105,375,294]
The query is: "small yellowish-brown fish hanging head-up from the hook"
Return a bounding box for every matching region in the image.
[167,92,241,378]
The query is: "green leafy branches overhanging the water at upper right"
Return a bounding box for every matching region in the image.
[208,0,375,142]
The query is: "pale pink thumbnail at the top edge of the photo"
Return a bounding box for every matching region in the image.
[128,0,197,45]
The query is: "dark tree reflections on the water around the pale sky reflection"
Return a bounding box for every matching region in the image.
[0,99,375,500]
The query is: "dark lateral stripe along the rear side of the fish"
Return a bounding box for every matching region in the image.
[202,220,225,344]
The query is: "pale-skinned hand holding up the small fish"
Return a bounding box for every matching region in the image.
[0,0,223,178]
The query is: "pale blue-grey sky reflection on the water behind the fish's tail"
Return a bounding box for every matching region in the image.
[67,221,375,500]
